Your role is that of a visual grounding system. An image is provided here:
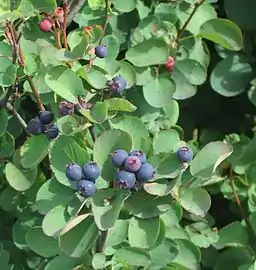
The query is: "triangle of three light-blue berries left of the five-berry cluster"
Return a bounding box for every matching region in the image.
[66,162,100,198]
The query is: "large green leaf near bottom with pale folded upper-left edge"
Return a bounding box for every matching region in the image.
[59,214,99,258]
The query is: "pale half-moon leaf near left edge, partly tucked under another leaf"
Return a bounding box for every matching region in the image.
[5,162,35,191]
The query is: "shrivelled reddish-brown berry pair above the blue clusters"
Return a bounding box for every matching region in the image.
[58,100,92,116]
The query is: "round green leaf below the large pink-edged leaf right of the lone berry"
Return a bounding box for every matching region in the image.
[179,188,211,217]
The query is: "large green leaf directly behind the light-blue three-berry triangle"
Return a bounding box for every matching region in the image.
[50,136,90,186]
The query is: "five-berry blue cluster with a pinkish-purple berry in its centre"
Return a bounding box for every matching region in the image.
[112,150,155,189]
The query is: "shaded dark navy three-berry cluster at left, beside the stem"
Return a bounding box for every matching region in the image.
[27,111,59,140]
